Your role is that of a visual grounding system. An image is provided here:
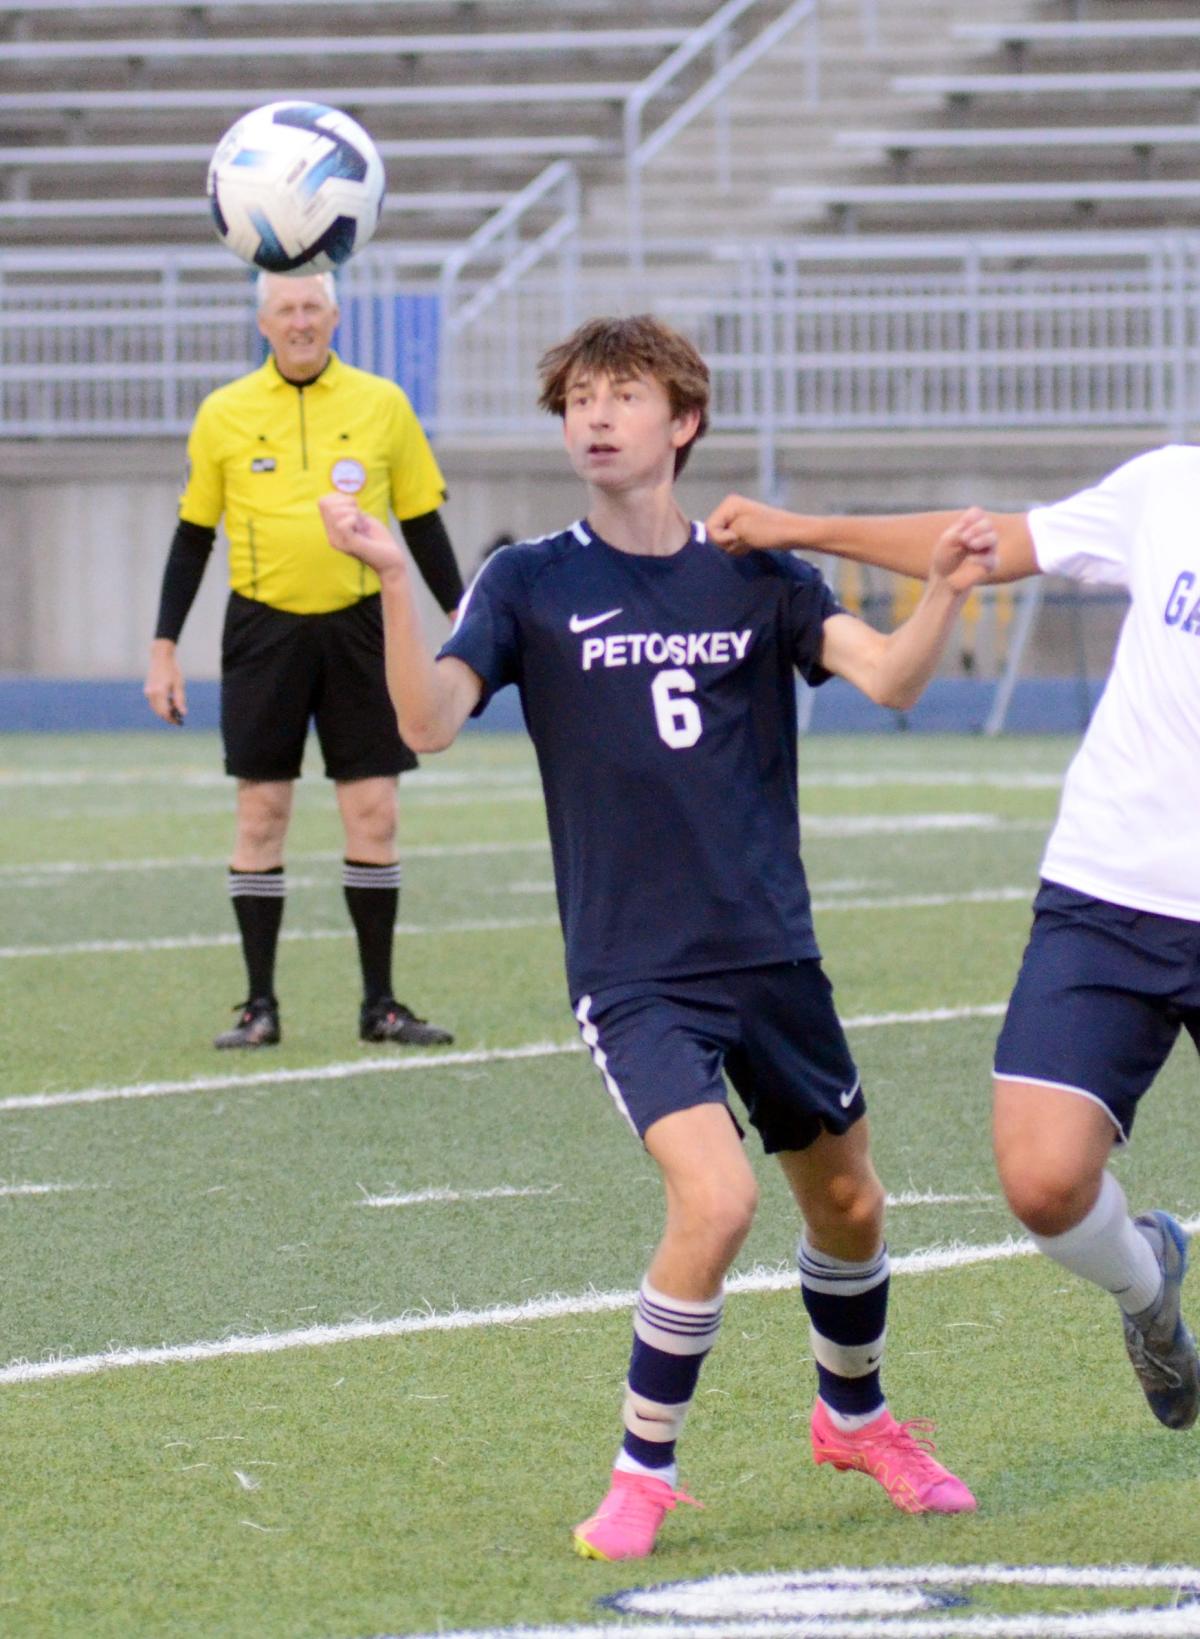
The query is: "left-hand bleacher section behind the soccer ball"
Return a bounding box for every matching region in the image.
[0,0,711,249]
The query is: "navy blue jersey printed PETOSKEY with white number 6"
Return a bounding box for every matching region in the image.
[441,523,839,1000]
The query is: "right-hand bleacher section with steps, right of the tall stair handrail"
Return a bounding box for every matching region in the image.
[619,0,1200,238]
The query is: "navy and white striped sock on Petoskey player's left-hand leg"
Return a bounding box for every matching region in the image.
[616,1280,725,1487]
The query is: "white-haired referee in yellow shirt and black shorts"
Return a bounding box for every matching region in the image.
[146,274,462,1047]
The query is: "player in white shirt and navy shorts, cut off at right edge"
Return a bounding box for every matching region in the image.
[708,446,1200,1429]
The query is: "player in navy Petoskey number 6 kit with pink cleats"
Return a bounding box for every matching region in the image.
[321,316,992,1560]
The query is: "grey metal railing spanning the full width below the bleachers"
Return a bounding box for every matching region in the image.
[0,227,1200,452]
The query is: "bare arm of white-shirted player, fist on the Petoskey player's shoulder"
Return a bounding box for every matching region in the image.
[707,495,1038,582]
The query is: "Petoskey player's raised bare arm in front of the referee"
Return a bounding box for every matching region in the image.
[318,493,484,751]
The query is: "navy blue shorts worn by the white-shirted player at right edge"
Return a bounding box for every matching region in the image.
[995,882,1200,1139]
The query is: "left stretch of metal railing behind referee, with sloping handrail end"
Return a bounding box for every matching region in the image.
[0,161,579,438]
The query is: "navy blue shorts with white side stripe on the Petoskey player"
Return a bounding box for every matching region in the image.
[575,959,867,1154]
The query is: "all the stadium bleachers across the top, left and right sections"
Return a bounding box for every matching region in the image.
[0,0,1200,246]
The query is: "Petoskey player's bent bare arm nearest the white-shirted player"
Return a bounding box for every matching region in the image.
[821,506,998,711]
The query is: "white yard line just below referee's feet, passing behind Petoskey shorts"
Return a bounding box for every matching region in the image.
[0,1001,1007,1113]
